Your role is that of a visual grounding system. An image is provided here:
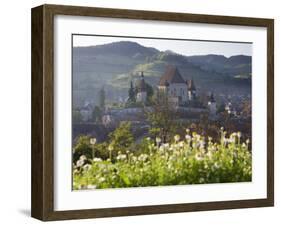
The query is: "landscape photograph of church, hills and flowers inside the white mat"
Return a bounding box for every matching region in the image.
[69,34,253,190]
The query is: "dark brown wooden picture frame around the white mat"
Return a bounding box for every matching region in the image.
[31,5,274,221]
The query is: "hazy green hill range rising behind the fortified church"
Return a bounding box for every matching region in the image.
[73,41,251,106]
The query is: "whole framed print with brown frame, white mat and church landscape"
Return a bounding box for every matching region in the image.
[32,5,274,221]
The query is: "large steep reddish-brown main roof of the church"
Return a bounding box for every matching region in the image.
[159,66,186,86]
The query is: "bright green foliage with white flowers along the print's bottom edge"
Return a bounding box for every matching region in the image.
[73,130,252,189]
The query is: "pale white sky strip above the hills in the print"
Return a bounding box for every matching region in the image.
[73,35,252,57]
